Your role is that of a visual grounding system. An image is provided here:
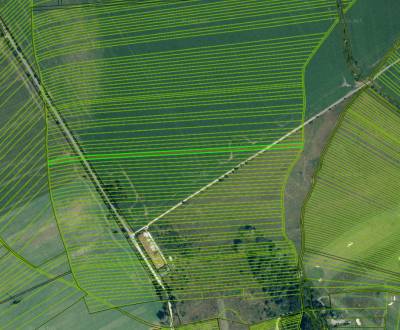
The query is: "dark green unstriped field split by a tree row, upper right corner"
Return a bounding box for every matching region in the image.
[305,0,400,118]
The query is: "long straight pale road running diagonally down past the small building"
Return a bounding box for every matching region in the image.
[0,17,174,329]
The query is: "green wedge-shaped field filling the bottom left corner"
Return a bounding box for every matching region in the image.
[0,240,84,330]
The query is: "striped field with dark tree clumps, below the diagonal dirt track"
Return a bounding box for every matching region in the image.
[149,135,299,324]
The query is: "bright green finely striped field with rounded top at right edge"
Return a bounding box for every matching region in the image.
[304,90,400,277]
